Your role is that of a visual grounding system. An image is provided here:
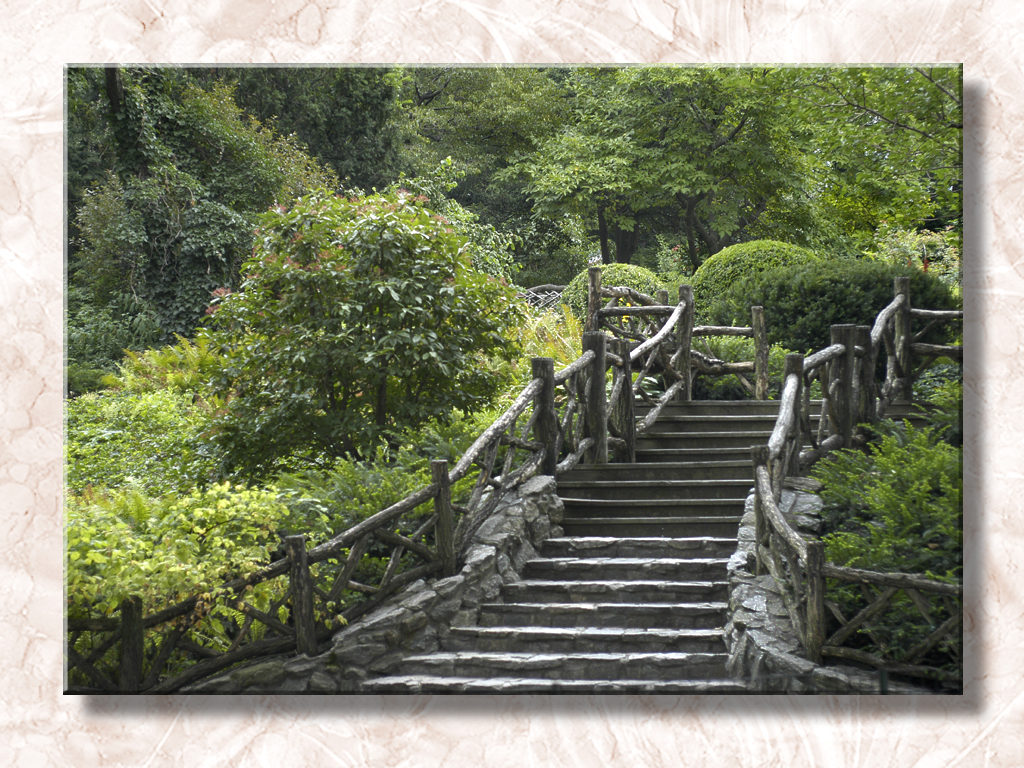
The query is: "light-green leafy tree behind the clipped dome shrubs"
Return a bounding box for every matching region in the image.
[505,68,804,268]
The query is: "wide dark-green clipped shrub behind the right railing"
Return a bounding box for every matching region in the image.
[712,259,963,356]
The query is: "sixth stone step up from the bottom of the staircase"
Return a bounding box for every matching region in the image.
[522,557,729,582]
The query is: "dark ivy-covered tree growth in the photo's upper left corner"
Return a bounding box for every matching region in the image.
[69,69,335,340]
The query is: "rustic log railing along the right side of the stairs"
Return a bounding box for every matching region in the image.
[753,278,964,683]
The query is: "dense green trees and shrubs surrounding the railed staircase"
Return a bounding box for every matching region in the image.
[66,67,963,684]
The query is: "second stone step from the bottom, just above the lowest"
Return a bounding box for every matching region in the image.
[387,651,728,681]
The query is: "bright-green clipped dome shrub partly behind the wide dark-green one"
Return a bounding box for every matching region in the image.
[691,240,819,326]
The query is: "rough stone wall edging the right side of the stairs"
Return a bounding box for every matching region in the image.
[725,490,934,694]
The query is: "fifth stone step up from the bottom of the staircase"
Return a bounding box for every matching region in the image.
[501,579,728,603]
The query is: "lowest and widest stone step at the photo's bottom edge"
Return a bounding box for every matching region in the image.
[362,675,749,695]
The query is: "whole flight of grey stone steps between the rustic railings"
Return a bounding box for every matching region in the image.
[364,401,933,693]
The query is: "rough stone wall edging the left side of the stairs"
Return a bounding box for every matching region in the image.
[185,476,563,693]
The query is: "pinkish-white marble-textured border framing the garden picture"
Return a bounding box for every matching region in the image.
[6,0,1024,768]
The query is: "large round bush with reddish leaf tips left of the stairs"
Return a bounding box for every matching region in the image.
[200,193,519,474]
